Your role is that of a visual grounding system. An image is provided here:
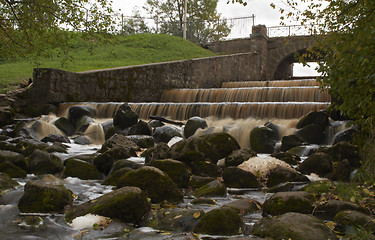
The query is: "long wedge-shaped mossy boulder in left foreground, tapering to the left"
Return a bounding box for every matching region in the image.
[65,187,150,225]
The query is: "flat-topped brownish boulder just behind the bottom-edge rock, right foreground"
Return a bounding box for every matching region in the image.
[263,191,315,215]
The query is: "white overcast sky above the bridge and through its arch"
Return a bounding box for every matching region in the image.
[113,0,316,76]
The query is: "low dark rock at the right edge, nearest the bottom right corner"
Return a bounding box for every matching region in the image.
[334,210,375,233]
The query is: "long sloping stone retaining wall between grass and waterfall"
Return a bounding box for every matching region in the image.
[28,53,262,111]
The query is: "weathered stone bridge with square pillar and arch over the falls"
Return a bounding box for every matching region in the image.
[202,25,317,80]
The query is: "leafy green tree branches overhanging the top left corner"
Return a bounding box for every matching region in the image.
[0,0,113,57]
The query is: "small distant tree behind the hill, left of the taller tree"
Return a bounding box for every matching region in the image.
[122,9,151,35]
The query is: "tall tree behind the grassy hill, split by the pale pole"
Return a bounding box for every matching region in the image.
[145,0,230,42]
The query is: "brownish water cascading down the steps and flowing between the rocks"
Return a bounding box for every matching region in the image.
[0,80,341,240]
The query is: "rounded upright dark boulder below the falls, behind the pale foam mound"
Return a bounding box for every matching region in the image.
[250,127,277,153]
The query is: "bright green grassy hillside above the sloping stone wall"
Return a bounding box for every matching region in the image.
[0,34,215,92]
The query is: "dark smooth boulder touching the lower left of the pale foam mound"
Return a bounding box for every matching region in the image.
[223,167,260,188]
